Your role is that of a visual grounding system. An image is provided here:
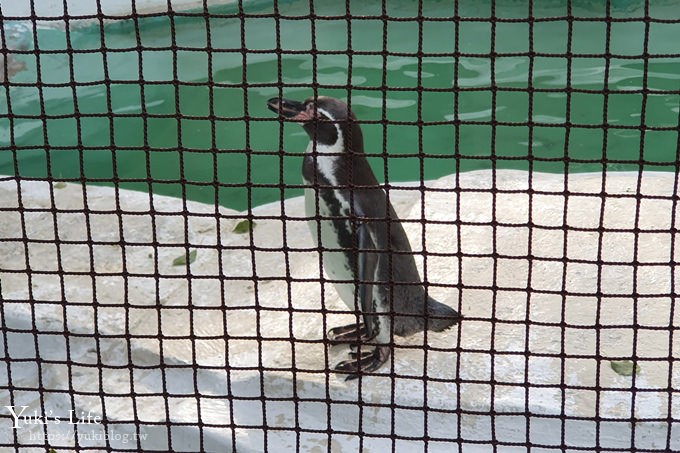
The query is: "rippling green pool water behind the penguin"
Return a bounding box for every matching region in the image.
[0,0,680,209]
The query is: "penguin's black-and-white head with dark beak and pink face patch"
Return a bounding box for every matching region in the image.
[267,96,363,152]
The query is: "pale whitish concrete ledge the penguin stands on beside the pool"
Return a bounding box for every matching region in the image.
[0,171,680,452]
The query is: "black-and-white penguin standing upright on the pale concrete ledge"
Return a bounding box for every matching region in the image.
[267,96,461,379]
